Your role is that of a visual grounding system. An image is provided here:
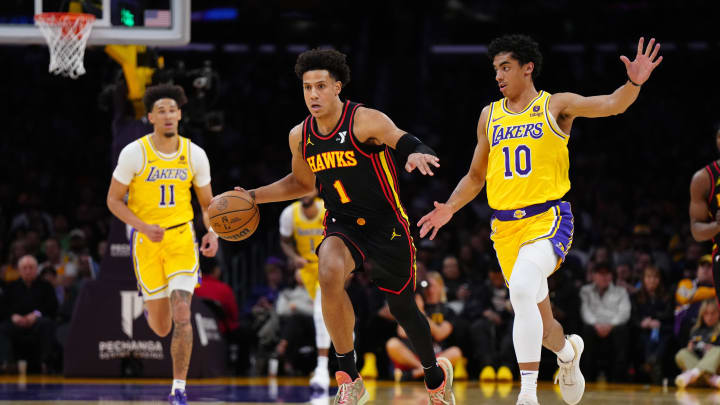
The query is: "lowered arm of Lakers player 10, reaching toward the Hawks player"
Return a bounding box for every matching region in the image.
[417,106,490,240]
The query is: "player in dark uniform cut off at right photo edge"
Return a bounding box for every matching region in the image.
[690,126,720,297]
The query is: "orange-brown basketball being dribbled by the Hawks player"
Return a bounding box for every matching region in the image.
[208,190,260,242]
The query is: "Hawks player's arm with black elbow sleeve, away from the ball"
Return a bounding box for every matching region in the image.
[353,108,440,176]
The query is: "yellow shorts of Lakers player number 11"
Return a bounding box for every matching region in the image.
[130,221,200,300]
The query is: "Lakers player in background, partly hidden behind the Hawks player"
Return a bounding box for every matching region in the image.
[280,193,330,390]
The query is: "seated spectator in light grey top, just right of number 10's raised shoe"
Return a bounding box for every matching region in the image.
[580,262,630,381]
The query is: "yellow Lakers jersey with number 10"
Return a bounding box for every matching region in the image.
[486,91,570,210]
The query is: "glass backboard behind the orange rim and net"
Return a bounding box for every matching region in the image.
[0,0,191,46]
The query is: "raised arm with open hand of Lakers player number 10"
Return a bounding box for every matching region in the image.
[550,38,663,118]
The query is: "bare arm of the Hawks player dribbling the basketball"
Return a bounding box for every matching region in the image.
[250,124,315,204]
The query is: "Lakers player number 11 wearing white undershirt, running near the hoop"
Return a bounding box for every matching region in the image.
[107,85,218,405]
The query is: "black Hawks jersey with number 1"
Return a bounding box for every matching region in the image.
[303,101,409,224]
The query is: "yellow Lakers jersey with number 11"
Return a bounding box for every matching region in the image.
[128,134,193,228]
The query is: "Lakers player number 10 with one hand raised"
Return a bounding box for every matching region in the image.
[418,35,662,404]
